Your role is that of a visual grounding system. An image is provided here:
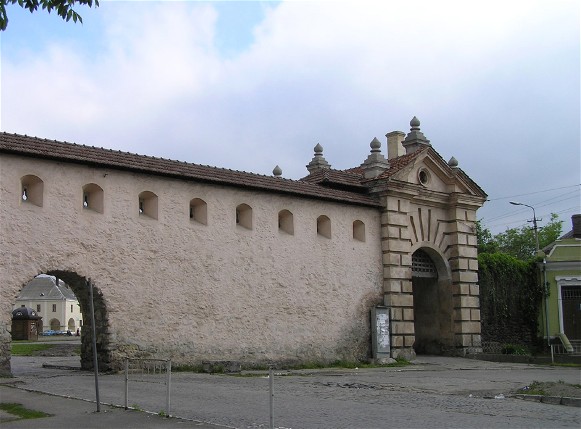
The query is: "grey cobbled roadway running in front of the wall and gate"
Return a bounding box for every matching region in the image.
[4,357,581,429]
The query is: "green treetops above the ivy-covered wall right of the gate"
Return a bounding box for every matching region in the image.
[476,213,563,261]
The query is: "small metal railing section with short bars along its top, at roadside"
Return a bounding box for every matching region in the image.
[125,359,171,416]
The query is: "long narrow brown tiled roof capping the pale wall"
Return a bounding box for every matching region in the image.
[0,133,380,207]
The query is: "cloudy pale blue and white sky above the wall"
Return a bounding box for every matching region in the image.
[0,0,581,233]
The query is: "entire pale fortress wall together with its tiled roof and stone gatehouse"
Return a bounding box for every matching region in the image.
[0,118,486,373]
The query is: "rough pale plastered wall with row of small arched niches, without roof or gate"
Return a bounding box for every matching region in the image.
[0,154,382,368]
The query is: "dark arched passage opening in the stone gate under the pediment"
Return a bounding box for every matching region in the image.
[412,247,454,355]
